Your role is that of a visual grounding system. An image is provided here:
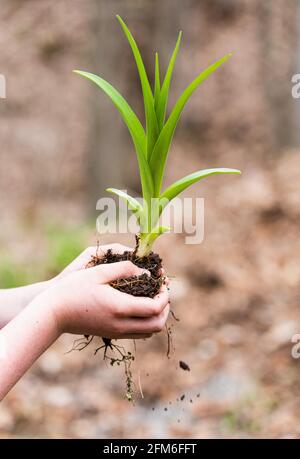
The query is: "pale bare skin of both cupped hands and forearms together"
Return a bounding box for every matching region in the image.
[0,244,169,400]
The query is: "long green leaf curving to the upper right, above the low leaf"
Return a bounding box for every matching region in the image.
[150,54,231,196]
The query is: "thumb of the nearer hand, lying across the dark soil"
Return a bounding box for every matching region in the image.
[91,261,150,284]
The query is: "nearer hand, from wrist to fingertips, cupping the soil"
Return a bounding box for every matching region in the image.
[43,261,169,338]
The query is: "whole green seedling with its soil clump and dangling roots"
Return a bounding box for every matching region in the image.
[73,16,240,400]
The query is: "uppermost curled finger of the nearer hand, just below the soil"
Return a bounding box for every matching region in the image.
[114,285,169,318]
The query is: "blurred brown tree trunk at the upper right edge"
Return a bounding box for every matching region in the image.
[257,0,299,149]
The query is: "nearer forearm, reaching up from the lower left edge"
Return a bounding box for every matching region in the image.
[0,295,59,400]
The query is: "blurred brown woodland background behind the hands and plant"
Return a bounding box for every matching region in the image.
[0,0,300,438]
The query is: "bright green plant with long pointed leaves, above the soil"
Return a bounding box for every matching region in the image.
[74,16,240,257]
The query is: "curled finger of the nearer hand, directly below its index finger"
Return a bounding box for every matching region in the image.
[122,305,170,334]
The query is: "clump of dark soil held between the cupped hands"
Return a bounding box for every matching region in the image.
[86,249,164,298]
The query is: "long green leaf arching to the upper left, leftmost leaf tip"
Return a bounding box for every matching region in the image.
[74,70,153,201]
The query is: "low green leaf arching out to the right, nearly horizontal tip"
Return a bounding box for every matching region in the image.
[160,167,241,213]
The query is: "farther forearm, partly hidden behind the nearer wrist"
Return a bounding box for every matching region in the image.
[0,281,52,329]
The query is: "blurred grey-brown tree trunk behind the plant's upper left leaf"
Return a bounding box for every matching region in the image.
[86,0,129,213]
